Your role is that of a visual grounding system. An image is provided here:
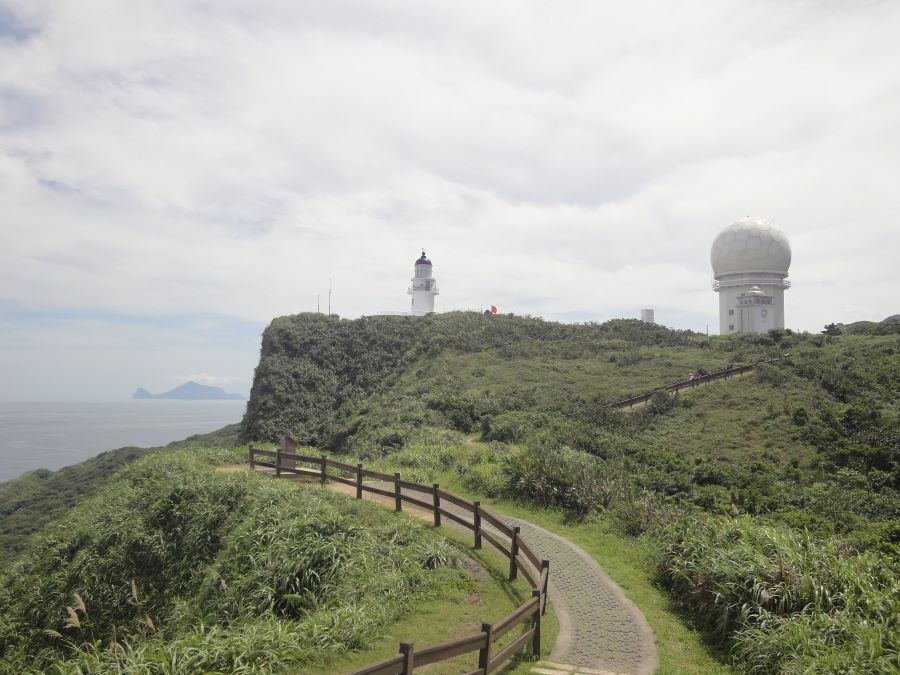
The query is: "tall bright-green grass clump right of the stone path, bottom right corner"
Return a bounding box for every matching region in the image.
[659,517,900,673]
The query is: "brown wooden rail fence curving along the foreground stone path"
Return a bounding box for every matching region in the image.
[249,444,550,675]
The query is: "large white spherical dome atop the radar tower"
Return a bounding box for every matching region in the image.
[710,218,791,279]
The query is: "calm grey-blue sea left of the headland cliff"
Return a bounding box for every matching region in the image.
[0,400,247,482]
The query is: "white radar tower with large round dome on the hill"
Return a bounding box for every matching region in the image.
[710,218,791,335]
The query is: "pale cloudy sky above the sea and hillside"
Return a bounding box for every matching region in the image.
[0,0,900,400]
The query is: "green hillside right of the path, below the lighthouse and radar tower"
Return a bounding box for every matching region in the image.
[244,313,900,672]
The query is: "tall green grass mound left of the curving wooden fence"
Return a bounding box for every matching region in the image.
[0,452,461,673]
